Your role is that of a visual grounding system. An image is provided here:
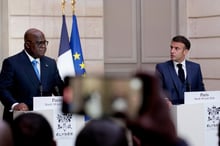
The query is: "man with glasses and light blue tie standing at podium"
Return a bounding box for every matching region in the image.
[0,28,63,123]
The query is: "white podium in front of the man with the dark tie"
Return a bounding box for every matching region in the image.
[171,91,220,146]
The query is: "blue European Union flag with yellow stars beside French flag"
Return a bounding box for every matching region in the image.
[70,14,86,76]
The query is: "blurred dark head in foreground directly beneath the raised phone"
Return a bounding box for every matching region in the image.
[75,119,128,146]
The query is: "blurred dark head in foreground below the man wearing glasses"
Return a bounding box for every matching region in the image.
[12,113,56,146]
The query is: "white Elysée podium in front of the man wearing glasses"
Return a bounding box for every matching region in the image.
[14,96,85,146]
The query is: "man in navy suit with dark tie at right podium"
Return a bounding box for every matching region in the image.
[156,35,205,104]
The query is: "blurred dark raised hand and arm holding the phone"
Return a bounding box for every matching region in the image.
[128,72,187,146]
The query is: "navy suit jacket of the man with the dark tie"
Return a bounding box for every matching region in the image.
[156,60,205,104]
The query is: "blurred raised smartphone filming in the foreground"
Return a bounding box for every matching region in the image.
[62,76,143,118]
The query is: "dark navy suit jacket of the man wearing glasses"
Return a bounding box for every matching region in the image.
[0,51,63,120]
